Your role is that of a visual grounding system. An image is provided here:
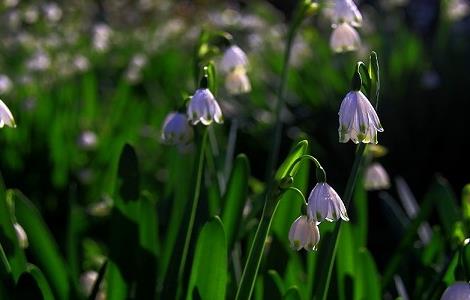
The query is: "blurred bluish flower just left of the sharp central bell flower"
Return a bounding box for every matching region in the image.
[161,112,194,145]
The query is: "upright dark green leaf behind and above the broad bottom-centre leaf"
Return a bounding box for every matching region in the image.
[222,154,250,249]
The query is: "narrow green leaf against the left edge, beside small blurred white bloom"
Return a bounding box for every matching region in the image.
[0,188,26,281]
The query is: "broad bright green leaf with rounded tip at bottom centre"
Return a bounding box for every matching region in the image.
[186,217,227,300]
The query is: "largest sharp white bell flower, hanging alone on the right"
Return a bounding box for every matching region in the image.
[338,91,383,144]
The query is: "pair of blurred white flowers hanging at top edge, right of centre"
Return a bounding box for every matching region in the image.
[330,0,362,52]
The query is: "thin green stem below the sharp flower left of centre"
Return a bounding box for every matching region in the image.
[176,128,207,299]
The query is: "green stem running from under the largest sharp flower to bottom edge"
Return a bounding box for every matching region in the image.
[315,143,366,300]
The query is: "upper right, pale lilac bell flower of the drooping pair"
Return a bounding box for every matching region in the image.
[307,182,349,222]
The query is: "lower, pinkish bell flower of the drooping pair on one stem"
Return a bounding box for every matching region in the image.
[289,216,320,251]
